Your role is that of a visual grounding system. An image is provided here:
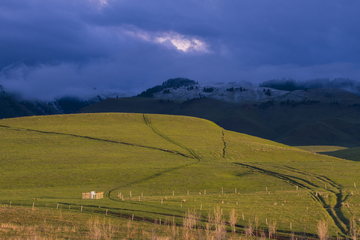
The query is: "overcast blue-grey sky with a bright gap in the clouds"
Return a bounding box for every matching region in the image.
[0,0,360,100]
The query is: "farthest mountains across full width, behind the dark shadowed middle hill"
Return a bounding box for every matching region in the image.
[0,77,360,118]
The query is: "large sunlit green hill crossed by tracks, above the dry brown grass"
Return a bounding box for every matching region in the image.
[0,113,360,238]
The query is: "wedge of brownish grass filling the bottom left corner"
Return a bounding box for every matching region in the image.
[0,205,186,239]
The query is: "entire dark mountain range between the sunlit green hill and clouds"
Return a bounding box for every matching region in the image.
[0,78,360,147]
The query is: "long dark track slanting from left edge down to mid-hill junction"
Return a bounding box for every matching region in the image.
[0,125,191,158]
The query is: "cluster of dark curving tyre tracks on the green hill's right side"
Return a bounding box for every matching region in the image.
[234,163,349,235]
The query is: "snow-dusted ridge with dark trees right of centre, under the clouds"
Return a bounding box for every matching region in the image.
[134,78,360,104]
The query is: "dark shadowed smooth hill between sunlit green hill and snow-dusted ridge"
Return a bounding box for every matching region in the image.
[80,97,360,147]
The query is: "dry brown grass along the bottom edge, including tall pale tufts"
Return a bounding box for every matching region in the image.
[0,206,344,240]
